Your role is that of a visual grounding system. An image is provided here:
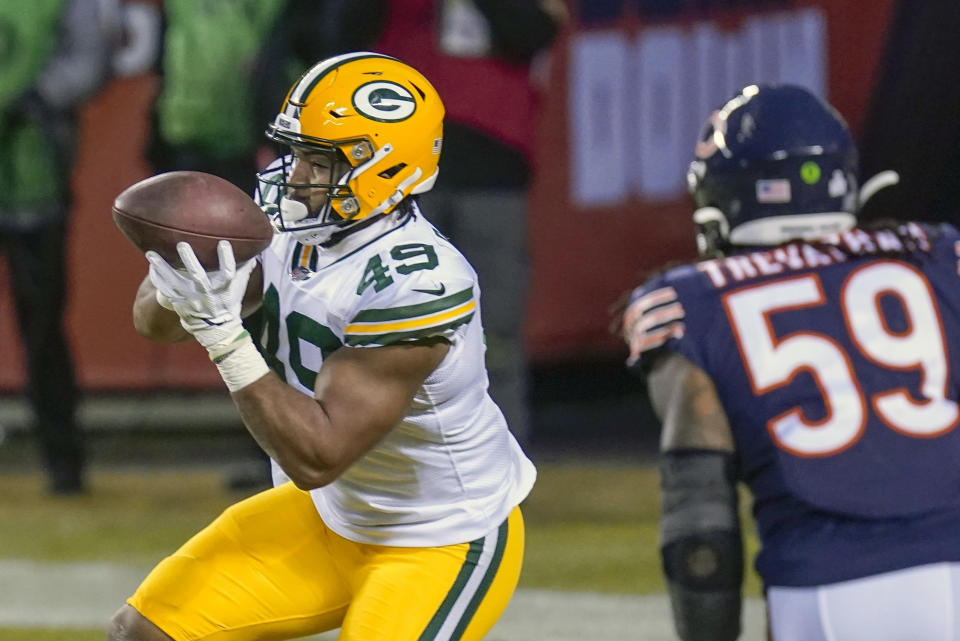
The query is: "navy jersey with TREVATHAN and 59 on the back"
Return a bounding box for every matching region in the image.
[627,224,960,585]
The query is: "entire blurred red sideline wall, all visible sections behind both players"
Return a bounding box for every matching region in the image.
[0,0,893,390]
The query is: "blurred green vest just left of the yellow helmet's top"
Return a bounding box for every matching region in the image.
[157,0,287,159]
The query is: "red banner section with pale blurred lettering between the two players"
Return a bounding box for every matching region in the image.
[527,0,893,361]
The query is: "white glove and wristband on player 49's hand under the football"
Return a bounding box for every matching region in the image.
[146,240,268,391]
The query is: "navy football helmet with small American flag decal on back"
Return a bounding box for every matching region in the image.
[687,85,858,256]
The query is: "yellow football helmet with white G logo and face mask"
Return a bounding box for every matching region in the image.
[258,51,444,244]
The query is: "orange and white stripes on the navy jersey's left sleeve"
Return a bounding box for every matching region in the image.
[623,287,686,365]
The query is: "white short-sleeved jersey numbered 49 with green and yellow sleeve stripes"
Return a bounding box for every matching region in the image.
[255,199,536,547]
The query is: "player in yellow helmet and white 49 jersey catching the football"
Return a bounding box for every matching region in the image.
[109,52,536,641]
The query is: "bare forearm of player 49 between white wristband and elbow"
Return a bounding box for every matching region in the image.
[232,372,347,490]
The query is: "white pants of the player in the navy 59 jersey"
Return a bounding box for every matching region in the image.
[767,563,960,641]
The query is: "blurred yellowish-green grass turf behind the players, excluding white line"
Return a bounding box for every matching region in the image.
[0,460,758,641]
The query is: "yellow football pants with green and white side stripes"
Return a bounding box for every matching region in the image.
[128,483,524,641]
